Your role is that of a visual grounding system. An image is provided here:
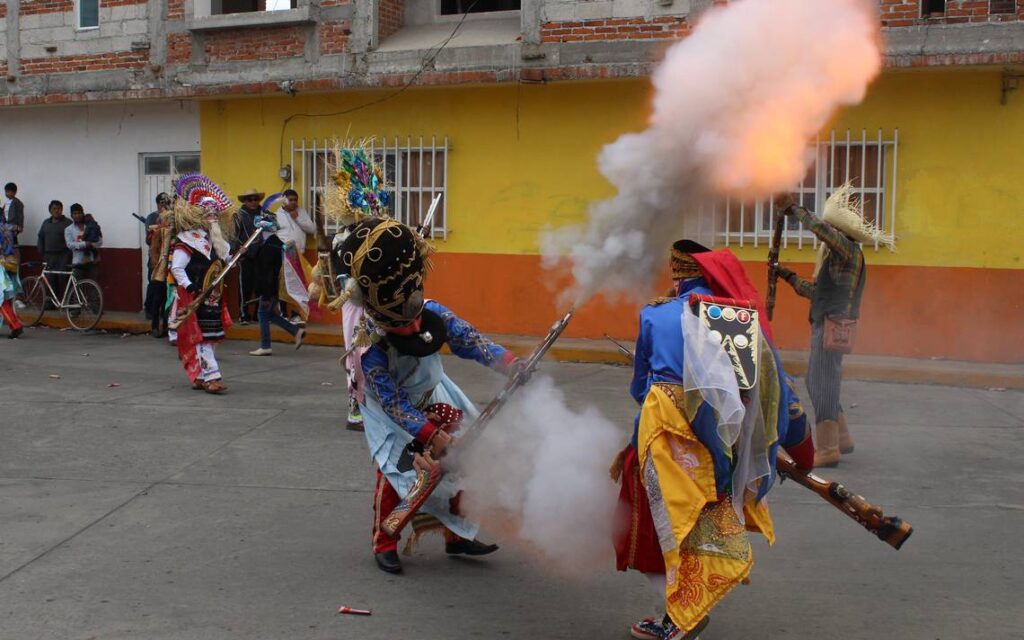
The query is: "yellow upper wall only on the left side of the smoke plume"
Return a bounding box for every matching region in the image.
[194,80,647,254]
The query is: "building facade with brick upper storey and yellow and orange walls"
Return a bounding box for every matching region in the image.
[0,0,1024,361]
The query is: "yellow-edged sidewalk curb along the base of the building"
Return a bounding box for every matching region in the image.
[40,314,1024,390]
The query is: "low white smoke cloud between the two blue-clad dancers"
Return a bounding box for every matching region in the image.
[459,376,628,574]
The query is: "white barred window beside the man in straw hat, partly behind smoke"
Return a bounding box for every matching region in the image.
[697,129,899,250]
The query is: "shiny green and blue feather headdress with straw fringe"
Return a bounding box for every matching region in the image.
[324,140,391,225]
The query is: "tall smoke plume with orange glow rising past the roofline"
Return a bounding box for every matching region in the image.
[541,0,882,300]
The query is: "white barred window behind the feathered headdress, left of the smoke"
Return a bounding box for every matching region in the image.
[291,136,451,240]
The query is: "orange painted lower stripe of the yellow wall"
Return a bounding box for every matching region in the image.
[417,253,1024,362]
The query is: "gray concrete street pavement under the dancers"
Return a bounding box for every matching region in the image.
[0,329,1024,640]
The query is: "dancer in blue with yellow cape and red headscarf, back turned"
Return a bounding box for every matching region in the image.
[612,241,813,640]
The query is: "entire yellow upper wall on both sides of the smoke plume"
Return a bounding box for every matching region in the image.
[201,69,1024,268]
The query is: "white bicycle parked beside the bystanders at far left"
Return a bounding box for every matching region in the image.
[20,262,103,331]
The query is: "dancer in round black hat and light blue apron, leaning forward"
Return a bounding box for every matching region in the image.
[338,218,515,572]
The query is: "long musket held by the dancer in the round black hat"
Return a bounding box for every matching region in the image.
[381,307,575,537]
